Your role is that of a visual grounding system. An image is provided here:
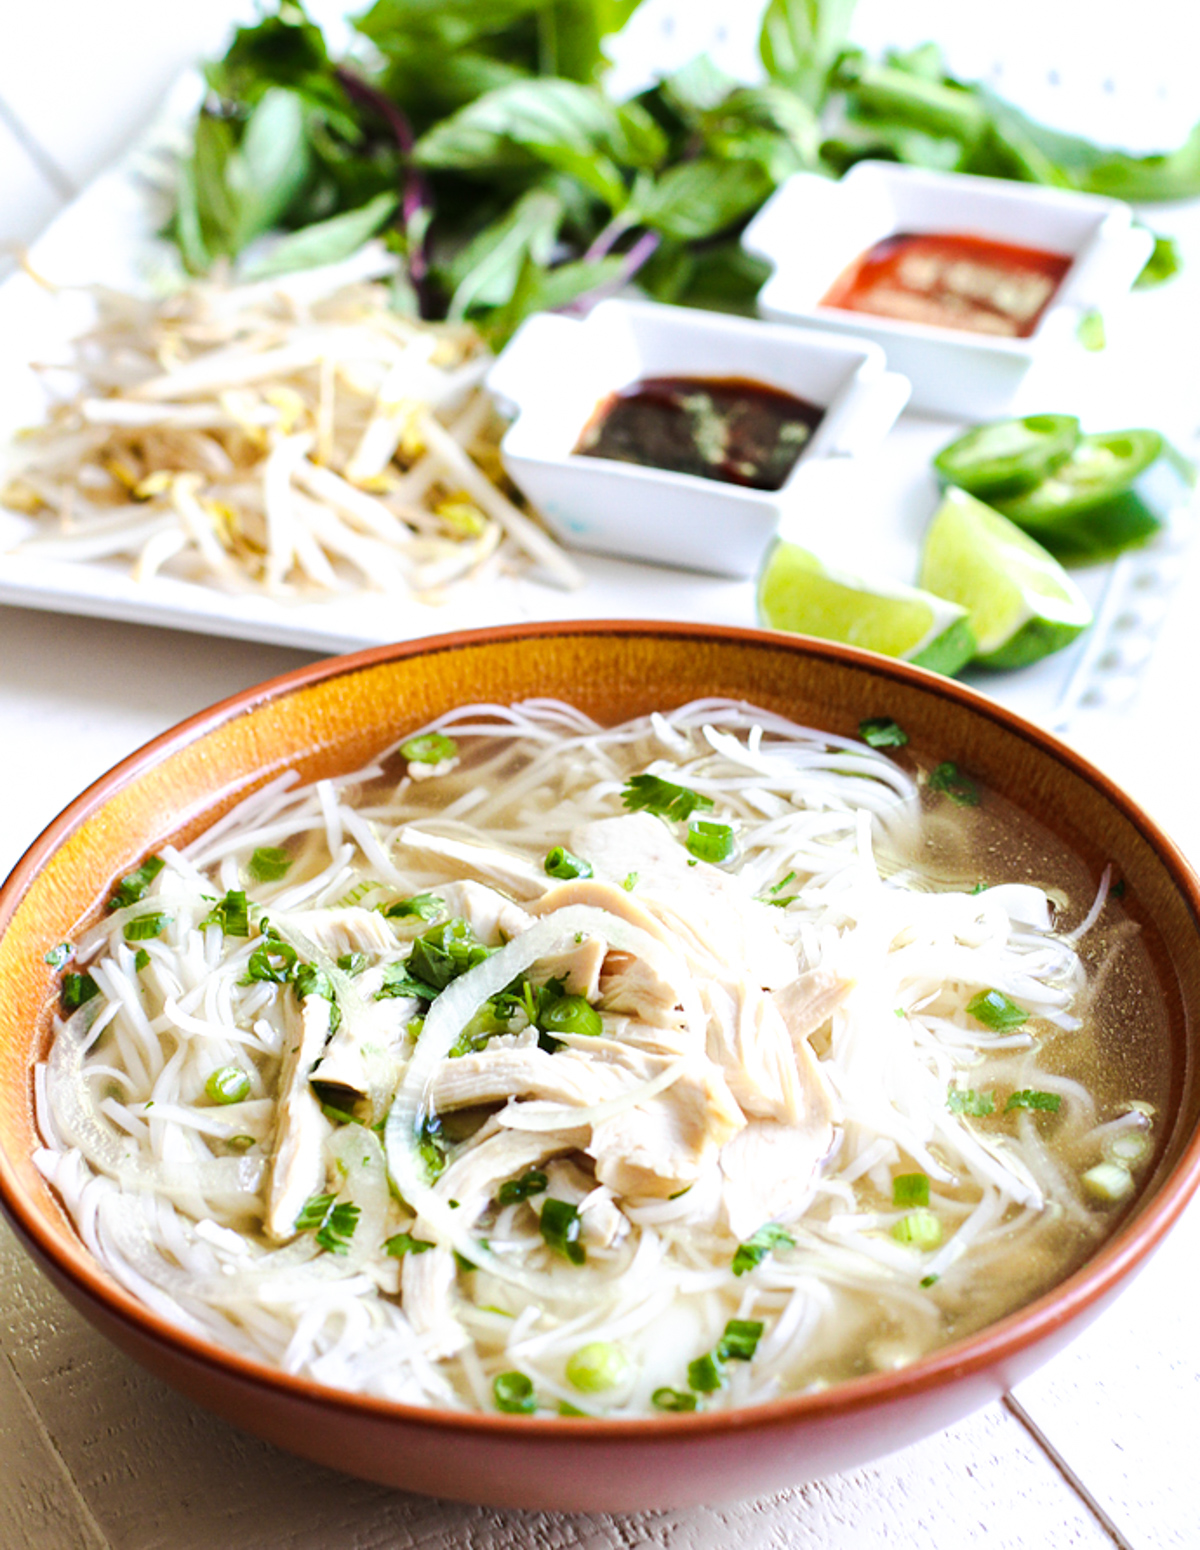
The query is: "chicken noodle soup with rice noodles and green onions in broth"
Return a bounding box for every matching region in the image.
[37,701,1166,1417]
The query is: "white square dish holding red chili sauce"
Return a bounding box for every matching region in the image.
[743,161,1153,419]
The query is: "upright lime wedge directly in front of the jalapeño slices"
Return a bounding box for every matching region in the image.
[921,490,1091,668]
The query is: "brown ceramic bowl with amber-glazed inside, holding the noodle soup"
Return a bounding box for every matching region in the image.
[0,623,1200,1510]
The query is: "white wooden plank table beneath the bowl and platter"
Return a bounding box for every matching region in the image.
[0,0,1200,1550]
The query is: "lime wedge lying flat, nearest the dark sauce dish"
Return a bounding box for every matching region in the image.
[758,541,975,674]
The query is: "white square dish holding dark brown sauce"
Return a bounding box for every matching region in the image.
[487,299,909,577]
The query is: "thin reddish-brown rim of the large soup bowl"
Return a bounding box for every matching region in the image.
[0,618,1200,1443]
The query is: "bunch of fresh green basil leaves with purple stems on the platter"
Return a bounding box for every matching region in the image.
[169,0,1200,344]
